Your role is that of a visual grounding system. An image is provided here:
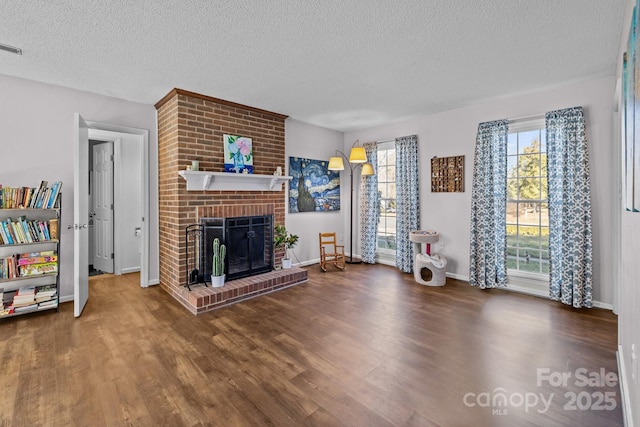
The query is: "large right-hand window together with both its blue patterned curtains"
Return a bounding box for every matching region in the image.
[469,107,593,308]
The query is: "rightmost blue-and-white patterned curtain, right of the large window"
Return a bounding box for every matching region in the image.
[545,107,593,308]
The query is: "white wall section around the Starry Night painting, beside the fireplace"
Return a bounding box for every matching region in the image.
[285,118,349,265]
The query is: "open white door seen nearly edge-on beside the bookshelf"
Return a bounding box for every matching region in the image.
[74,113,89,317]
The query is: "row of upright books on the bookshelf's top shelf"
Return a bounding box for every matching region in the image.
[0,181,62,209]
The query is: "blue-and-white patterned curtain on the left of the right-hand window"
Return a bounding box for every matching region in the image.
[469,120,509,289]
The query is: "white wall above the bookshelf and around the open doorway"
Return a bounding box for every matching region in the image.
[0,75,159,299]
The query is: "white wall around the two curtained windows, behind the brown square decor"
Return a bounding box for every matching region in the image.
[343,77,615,304]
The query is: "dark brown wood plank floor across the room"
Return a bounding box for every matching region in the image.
[0,265,622,427]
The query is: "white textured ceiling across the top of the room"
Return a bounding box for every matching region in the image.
[0,0,625,131]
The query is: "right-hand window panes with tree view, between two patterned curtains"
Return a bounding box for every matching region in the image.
[506,120,549,277]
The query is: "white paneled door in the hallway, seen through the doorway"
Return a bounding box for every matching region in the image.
[91,142,113,273]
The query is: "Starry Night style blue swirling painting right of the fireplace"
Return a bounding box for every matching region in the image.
[289,157,340,213]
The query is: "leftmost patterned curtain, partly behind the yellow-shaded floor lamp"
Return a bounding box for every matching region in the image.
[360,142,380,264]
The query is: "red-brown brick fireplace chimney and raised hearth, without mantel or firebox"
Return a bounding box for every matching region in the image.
[156,89,307,314]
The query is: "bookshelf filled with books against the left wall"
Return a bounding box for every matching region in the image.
[0,182,62,319]
